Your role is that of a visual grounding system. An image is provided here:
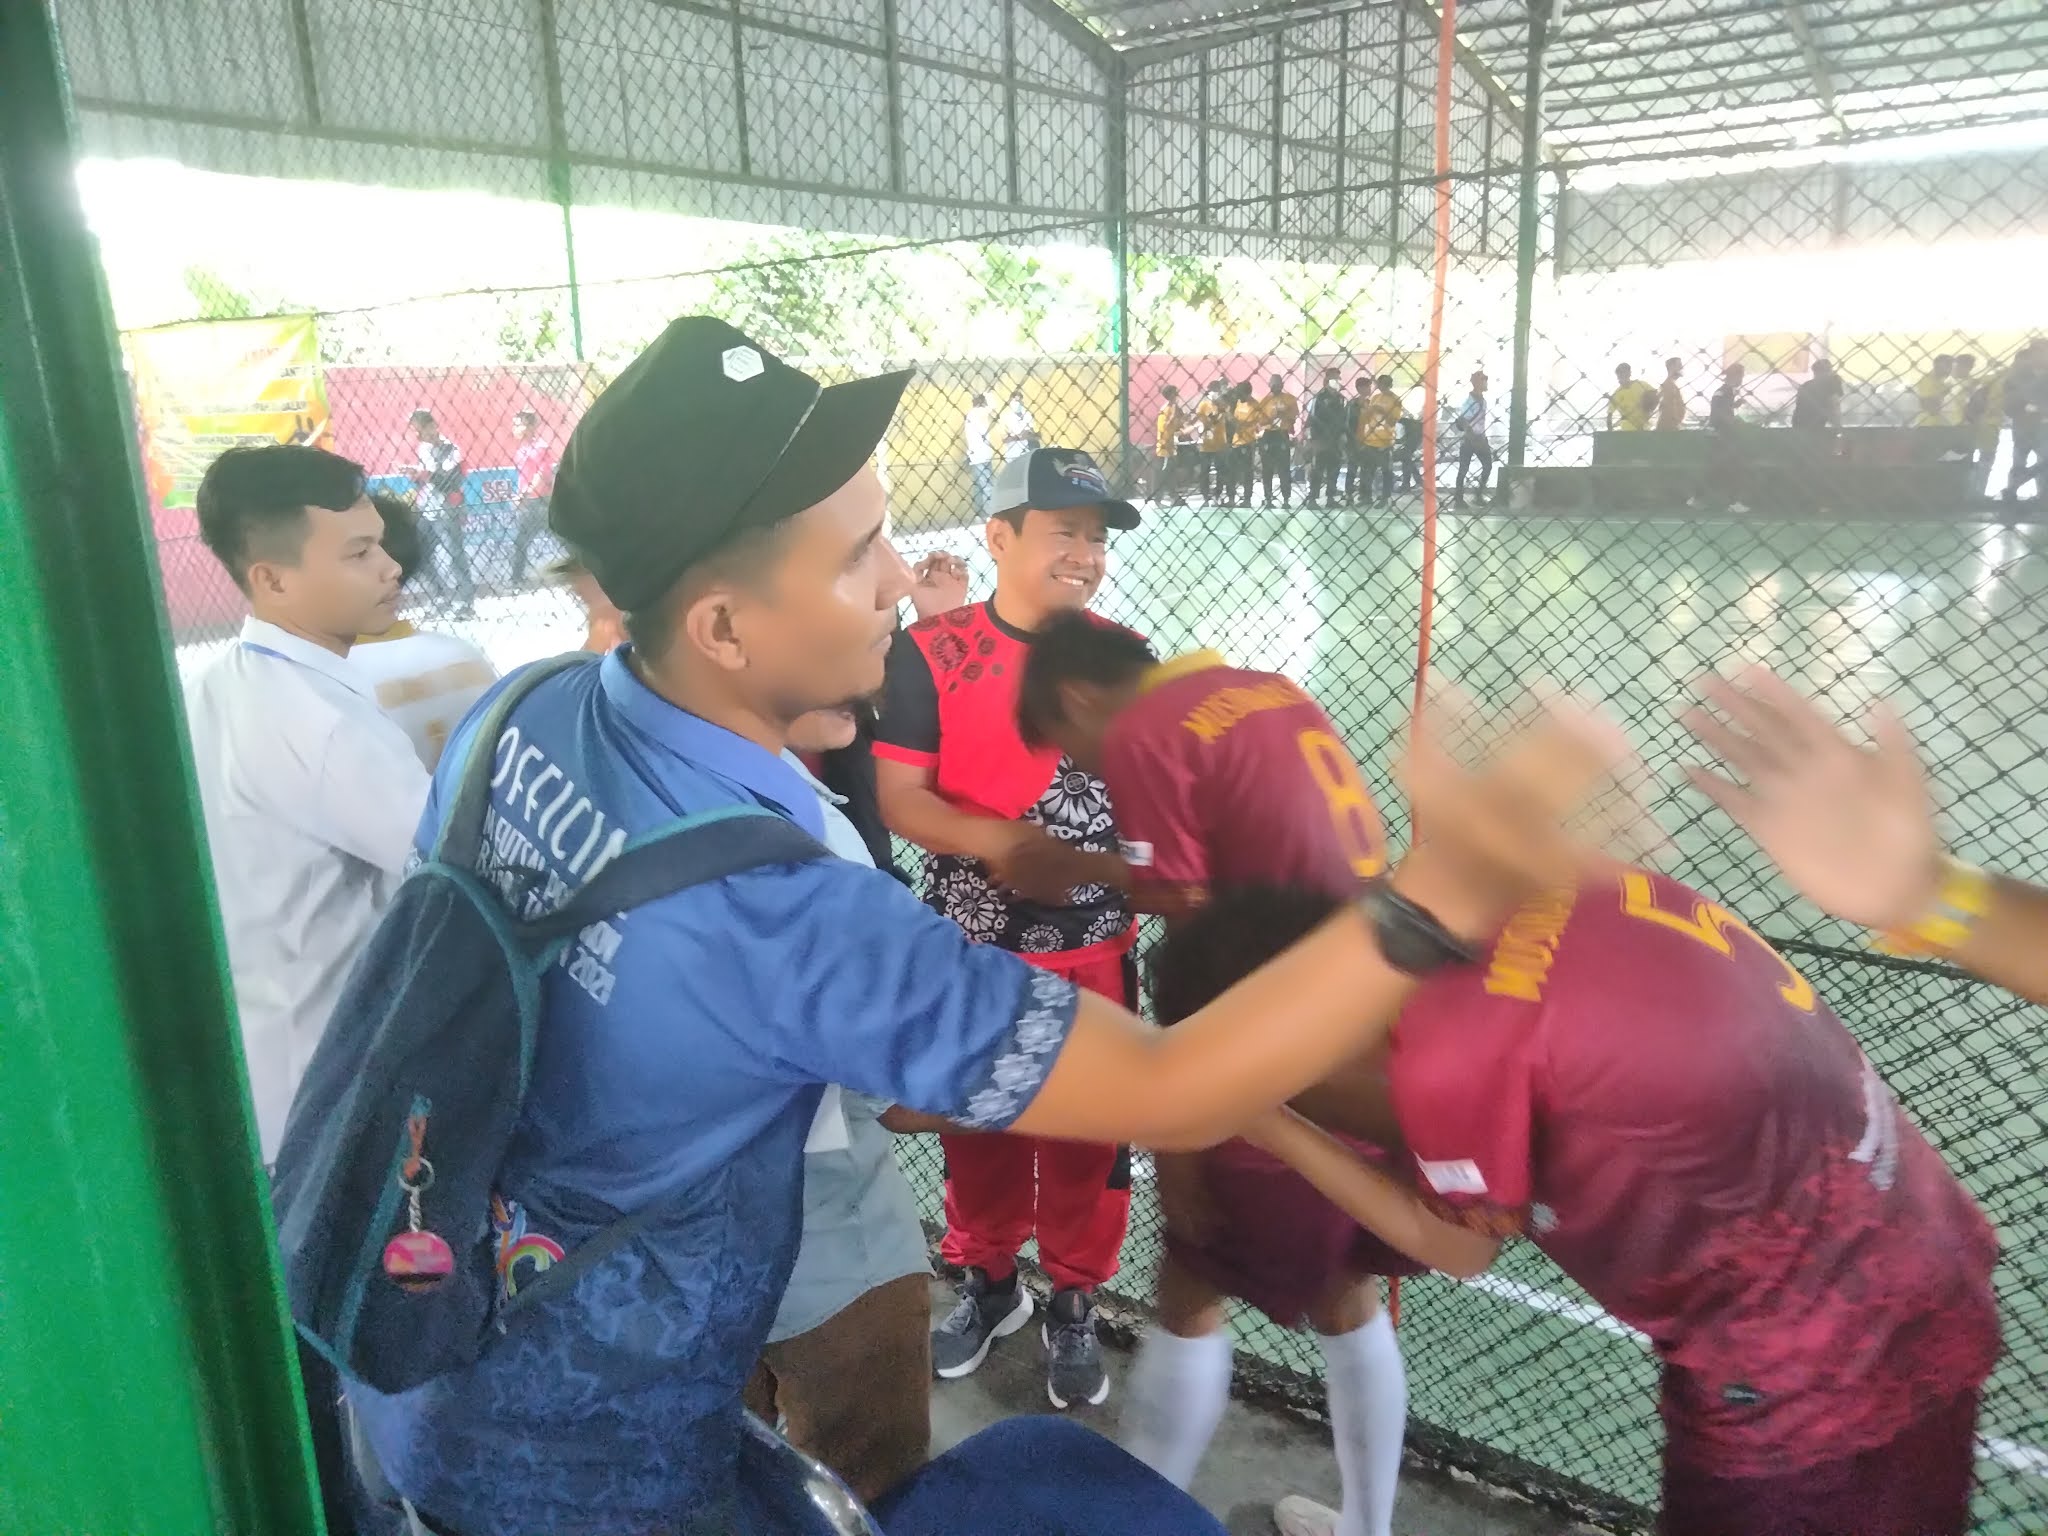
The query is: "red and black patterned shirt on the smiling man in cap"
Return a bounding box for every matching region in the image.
[874,602,1137,954]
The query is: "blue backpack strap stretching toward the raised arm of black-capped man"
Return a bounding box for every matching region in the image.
[520,805,831,940]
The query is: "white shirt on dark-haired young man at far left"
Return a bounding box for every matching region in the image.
[184,618,430,1163]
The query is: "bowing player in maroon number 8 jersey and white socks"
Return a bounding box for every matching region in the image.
[1018,614,1421,1536]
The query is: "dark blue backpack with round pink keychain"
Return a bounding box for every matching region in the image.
[272,655,827,1393]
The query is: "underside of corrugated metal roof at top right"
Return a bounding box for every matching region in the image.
[1061,0,2048,162]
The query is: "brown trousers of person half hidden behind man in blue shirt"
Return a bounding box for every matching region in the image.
[745,1274,932,1503]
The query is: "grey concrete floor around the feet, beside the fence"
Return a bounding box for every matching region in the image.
[932,1280,1581,1536]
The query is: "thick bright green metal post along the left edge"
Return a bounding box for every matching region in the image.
[0,4,322,1536]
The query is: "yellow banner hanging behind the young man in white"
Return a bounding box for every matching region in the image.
[123,315,330,510]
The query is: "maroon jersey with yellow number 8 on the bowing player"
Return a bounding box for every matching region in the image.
[1102,651,1386,895]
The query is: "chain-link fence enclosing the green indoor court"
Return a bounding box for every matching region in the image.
[57,0,2048,1536]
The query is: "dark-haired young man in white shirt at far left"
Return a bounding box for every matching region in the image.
[186,444,428,1163]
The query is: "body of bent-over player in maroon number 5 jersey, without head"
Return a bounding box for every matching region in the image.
[1247,870,1999,1536]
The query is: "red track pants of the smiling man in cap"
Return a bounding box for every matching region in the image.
[938,950,1133,1290]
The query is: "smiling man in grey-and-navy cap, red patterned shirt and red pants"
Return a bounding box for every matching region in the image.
[874,449,1139,1407]
